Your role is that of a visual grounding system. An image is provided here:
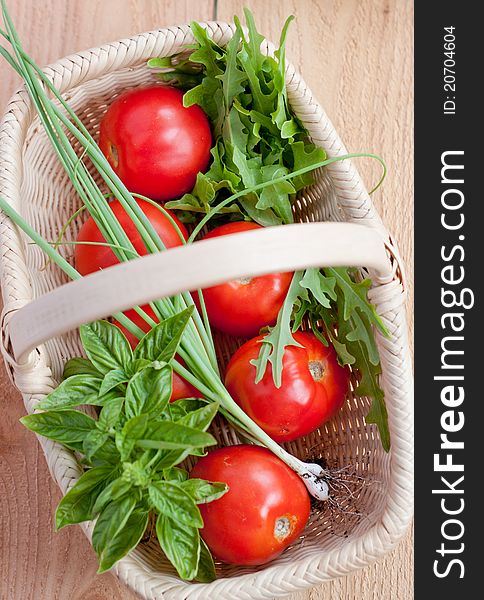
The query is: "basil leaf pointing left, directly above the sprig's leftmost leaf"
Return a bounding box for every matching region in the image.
[35,375,101,410]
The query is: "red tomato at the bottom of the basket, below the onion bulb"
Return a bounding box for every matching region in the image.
[190,445,310,565]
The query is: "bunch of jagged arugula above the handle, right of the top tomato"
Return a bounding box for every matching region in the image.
[148,10,325,226]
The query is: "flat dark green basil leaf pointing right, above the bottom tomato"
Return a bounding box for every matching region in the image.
[138,422,217,450]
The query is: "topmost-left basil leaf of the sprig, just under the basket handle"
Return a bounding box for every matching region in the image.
[80,321,133,375]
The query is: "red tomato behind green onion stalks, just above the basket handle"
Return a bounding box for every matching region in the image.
[74,200,188,275]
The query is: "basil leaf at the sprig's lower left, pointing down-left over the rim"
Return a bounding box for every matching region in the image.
[55,466,114,529]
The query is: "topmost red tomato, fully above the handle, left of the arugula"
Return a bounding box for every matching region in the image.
[99,86,212,200]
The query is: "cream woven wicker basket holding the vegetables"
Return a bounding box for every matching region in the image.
[0,22,413,600]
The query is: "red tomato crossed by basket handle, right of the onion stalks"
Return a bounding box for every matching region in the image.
[196,221,293,337]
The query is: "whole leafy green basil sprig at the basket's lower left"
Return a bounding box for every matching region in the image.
[21,309,228,582]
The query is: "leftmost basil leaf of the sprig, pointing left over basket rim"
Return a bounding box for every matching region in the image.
[20,410,96,444]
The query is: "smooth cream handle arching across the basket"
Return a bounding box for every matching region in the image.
[8,223,392,363]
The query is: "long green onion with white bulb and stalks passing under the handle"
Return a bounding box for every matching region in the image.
[0,0,383,500]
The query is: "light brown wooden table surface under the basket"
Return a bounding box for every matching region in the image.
[0,0,413,600]
